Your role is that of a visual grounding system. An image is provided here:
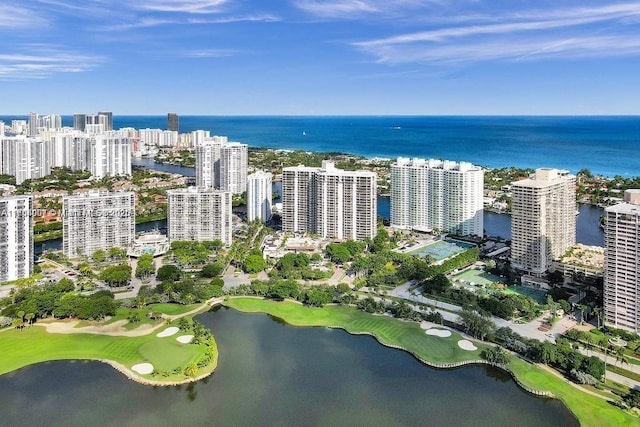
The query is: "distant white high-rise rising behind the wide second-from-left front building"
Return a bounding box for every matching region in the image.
[87,132,131,179]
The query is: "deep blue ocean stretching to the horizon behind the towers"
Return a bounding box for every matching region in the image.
[0,116,640,177]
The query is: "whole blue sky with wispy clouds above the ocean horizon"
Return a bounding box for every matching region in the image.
[0,0,640,115]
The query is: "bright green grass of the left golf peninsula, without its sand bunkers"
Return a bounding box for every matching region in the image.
[0,305,218,385]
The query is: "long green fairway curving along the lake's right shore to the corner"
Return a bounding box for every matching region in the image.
[224,297,640,427]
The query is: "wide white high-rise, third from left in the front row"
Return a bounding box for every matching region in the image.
[167,187,233,245]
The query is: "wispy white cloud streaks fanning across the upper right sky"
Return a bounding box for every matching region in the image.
[353,3,640,63]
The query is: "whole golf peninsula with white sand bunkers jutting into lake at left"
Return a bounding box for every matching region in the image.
[0,304,218,385]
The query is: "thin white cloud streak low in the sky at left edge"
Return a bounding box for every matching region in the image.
[0,45,104,80]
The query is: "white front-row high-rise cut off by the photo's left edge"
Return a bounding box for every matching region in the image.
[0,196,33,282]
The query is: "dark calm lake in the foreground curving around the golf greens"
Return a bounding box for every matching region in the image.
[0,308,578,427]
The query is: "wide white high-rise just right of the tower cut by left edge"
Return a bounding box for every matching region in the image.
[62,191,135,258]
